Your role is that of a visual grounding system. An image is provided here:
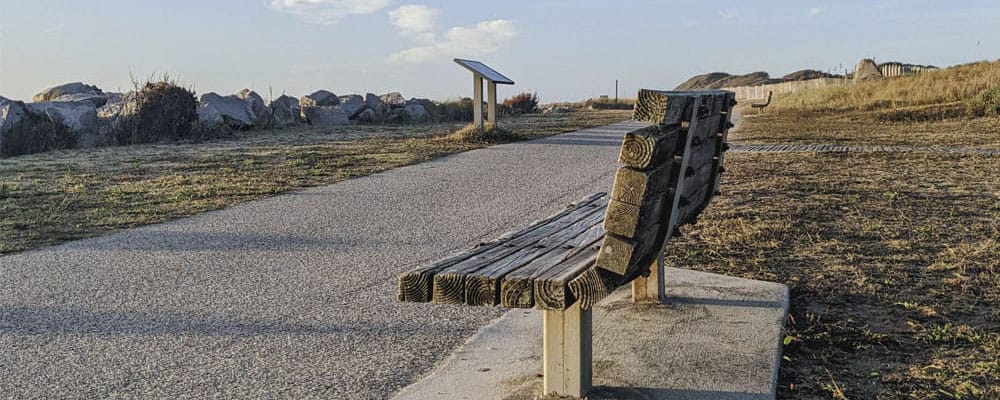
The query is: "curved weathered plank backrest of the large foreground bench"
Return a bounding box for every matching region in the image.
[570,89,736,308]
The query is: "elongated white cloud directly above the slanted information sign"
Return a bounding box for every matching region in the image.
[389,19,517,64]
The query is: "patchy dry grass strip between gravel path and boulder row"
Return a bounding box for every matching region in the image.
[0,111,629,254]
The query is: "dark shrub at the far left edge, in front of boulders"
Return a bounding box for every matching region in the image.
[0,105,77,157]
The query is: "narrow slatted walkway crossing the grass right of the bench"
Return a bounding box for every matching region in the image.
[731,144,1000,156]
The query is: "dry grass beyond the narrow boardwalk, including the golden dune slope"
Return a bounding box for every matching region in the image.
[733,61,1000,148]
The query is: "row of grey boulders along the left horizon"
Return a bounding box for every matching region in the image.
[0,82,435,157]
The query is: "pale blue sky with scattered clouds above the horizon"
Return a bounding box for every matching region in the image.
[0,0,1000,102]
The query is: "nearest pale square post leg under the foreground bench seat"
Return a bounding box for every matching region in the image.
[542,302,593,397]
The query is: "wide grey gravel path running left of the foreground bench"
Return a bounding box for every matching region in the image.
[0,123,648,399]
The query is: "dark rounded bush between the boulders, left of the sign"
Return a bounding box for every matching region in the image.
[112,79,204,145]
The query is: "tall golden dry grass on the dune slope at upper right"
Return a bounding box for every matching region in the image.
[771,61,1000,113]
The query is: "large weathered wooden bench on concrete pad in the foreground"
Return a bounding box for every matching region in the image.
[398,90,736,397]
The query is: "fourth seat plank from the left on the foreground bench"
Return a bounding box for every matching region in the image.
[500,225,604,308]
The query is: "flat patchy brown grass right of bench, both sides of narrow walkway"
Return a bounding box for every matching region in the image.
[670,98,1000,399]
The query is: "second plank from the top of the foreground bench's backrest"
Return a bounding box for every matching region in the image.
[618,124,680,171]
